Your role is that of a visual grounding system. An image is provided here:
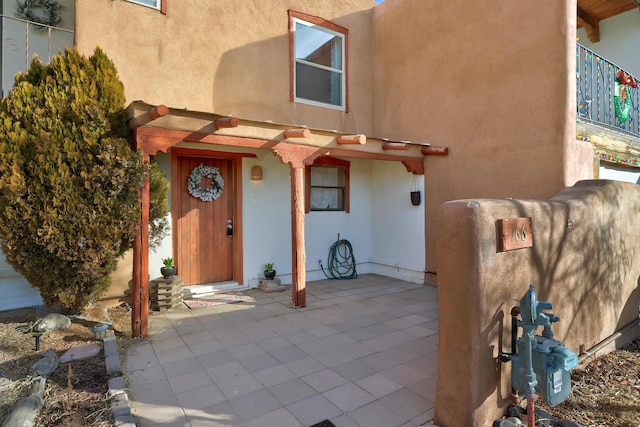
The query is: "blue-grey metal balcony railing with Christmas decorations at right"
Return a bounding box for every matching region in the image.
[576,43,640,136]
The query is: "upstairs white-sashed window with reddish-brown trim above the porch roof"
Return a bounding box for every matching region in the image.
[289,11,348,111]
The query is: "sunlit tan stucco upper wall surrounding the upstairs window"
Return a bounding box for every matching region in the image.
[76,0,375,134]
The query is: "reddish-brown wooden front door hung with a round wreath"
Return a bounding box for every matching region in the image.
[173,156,234,285]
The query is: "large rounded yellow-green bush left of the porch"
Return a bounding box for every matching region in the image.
[0,48,166,311]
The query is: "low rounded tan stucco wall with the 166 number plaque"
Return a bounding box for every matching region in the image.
[435,181,640,427]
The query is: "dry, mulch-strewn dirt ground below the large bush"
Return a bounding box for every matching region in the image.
[0,305,131,427]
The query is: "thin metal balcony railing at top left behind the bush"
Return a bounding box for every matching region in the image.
[0,13,73,96]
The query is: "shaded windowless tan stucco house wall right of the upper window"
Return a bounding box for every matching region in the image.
[373,0,593,270]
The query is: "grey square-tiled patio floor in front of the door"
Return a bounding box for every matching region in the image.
[124,274,438,427]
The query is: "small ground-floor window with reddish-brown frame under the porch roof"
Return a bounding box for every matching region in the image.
[305,157,350,212]
